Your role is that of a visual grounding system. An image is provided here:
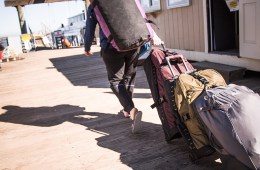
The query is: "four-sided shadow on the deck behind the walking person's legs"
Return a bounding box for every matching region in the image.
[50,53,149,88]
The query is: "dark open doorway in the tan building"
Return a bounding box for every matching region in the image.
[207,0,239,55]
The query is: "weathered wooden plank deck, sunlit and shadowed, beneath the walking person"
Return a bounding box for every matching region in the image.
[0,47,259,170]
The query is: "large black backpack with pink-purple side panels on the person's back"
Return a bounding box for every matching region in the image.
[91,0,154,51]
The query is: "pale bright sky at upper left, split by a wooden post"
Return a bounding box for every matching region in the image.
[0,0,85,36]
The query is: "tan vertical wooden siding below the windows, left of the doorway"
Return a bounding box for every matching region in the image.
[147,0,205,52]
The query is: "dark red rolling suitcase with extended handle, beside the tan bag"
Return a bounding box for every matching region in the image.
[143,45,214,160]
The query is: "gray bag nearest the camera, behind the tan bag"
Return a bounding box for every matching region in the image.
[192,84,260,169]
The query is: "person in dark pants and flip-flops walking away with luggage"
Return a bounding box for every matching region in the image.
[84,5,161,133]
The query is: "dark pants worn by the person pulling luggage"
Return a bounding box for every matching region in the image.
[101,49,139,112]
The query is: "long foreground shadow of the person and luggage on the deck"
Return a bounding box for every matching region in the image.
[0,105,221,170]
